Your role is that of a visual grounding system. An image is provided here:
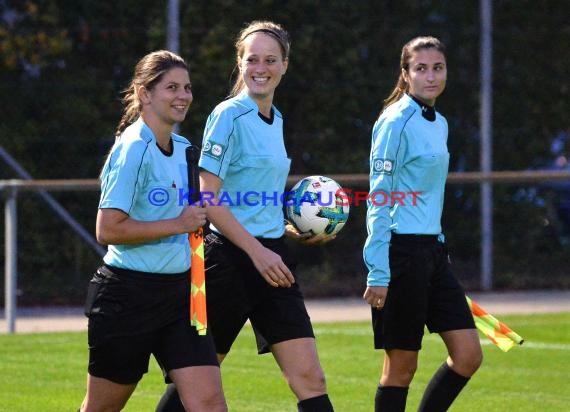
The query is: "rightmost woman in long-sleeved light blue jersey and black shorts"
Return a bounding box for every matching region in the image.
[364,37,483,412]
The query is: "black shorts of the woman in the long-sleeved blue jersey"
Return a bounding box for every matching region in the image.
[372,234,475,351]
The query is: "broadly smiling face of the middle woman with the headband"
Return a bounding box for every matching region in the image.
[238,32,288,105]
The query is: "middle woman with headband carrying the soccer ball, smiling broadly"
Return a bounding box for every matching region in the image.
[157,21,333,412]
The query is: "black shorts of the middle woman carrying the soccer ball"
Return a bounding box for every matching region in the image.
[204,233,315,354]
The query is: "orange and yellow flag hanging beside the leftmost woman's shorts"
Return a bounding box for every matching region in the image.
[189,228,208,335]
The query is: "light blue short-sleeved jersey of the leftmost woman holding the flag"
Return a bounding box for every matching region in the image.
[99,118,190,274]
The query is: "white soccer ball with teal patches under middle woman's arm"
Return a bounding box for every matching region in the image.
[285,176,350,235]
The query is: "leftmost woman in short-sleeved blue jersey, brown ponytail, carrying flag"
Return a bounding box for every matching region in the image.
[81,51,227,412]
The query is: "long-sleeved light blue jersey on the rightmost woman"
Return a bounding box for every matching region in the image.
[364,95,449,286]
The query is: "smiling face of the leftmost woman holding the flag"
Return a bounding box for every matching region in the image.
[139,67,193,128]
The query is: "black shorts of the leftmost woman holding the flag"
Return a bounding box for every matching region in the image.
[85,265,218,384]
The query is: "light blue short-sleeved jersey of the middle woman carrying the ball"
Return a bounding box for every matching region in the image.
[199,92,291,238]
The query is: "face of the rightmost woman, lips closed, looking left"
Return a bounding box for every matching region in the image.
[402,48,447,106]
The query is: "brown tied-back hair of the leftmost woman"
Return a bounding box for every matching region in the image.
[115,50,188,137]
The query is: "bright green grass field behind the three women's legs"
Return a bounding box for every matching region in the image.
[0,313,570,412]
